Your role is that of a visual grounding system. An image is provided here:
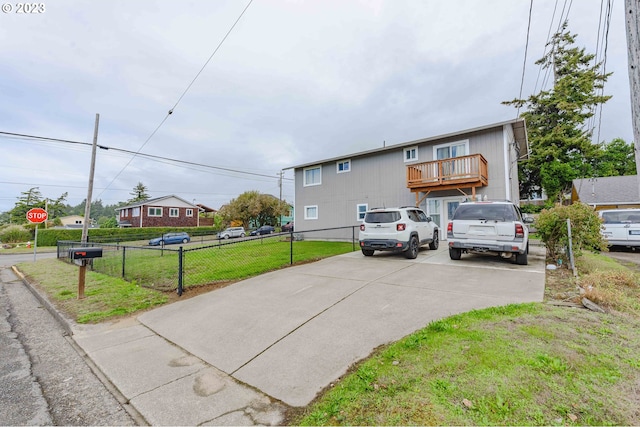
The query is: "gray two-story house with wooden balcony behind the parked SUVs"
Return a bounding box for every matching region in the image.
[292,119,528,237]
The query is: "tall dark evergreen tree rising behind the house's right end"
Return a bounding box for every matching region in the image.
[503,21,611,203]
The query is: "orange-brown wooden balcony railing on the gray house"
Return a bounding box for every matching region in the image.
[407,154,489,191]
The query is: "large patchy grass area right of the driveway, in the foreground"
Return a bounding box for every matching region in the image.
[288,254,640,425]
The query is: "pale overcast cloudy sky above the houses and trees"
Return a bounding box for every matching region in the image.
[0,0,633,212]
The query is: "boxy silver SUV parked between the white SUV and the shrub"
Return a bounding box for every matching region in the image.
[447,202,533,265]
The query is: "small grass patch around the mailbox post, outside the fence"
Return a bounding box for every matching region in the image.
[17,259,168,323]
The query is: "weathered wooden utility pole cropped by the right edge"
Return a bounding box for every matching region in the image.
[624,0,640,177]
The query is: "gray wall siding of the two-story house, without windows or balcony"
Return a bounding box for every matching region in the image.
[294,120,519,231]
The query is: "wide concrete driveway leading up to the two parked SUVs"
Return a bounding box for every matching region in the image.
[138,244,545,406]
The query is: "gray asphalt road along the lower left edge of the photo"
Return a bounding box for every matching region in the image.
[0,254,136,425]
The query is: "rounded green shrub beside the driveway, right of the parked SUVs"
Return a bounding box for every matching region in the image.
[535,203,607,262]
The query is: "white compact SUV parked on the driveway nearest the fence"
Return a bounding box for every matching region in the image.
[359,207,438,259]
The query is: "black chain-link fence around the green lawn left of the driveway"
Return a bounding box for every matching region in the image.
[57,226,359,295]
